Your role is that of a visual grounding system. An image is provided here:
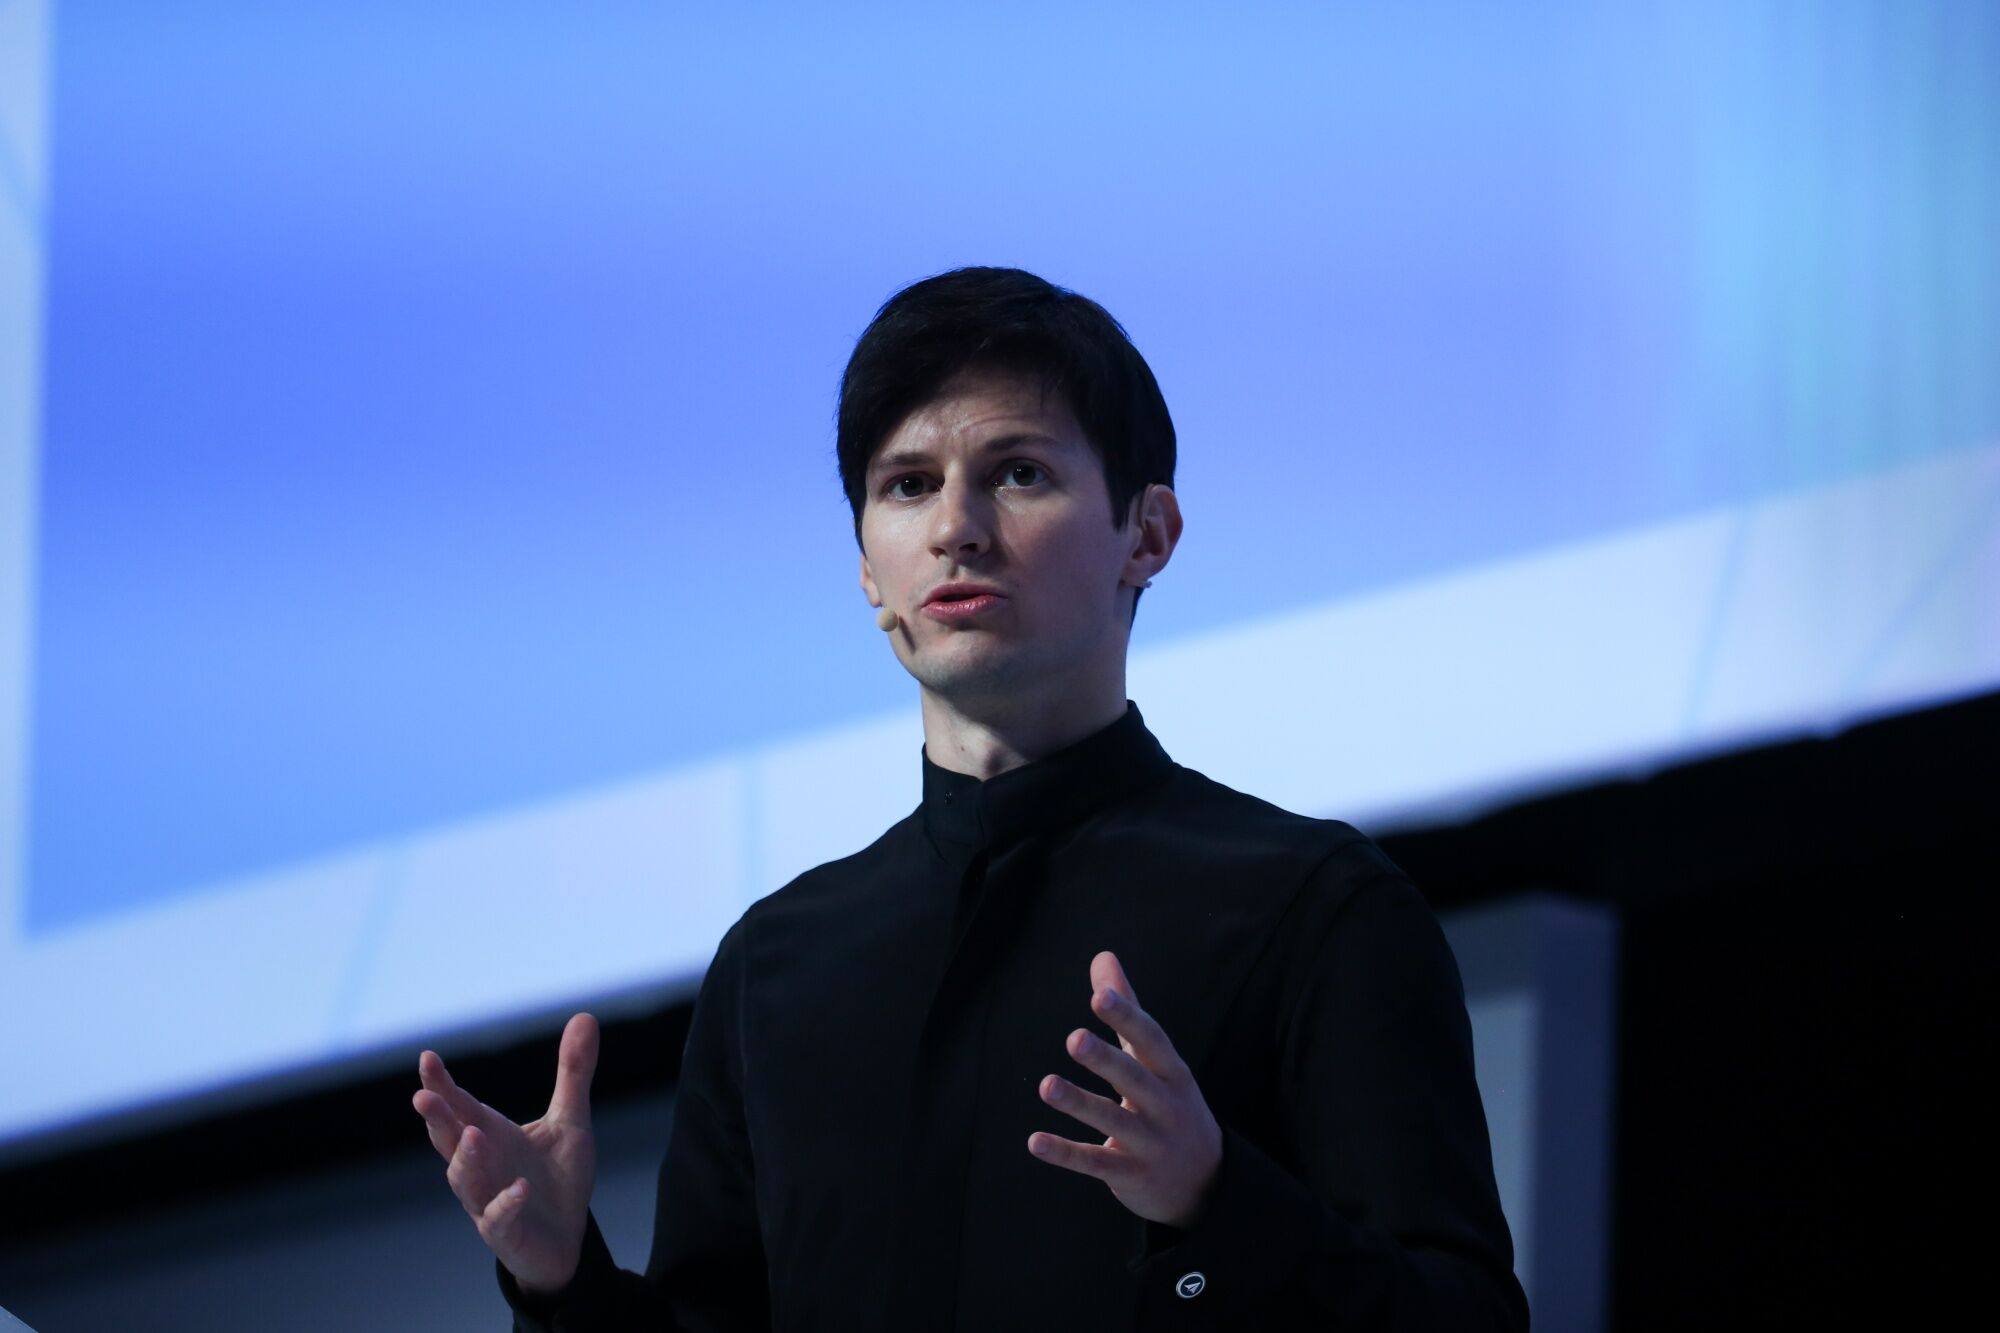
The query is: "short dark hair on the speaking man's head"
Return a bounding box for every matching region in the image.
[834,268,1174,614]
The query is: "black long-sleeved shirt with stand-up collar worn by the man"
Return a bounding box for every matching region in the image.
[496,701,1528,1331]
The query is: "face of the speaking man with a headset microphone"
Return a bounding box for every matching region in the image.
[862,358,1144,703]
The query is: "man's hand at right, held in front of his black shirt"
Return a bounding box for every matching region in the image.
[1028,949,1222,1229]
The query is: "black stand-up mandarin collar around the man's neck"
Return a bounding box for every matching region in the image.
[920,699,1174,849]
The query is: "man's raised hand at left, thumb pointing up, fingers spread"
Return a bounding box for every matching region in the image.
[410,1013,598,1295]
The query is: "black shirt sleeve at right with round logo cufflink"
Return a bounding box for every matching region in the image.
[1132,873,1528,1333]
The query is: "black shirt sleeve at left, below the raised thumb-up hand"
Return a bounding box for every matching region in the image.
[494,919,770,1333]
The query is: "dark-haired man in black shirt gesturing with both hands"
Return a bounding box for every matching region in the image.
[414,268,1528,1329]
